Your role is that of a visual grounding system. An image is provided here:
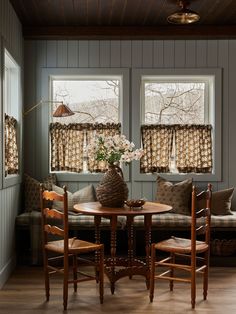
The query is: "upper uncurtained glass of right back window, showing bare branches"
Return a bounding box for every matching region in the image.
[144,82,205,124]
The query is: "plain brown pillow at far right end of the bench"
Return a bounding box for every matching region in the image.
[211,188,234,215]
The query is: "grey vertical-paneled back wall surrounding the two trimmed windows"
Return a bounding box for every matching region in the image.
[25,40,236,209]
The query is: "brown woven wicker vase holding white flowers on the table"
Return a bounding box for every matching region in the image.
[96,165,129,207]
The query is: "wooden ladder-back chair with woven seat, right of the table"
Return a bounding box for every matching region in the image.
[150,184,212,308]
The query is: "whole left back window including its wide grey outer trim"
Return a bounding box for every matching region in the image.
[42,68,129,181]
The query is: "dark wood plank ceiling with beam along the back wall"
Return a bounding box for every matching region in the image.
[10,0,236,39]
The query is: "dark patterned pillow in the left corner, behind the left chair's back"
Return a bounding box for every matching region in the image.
[24,174,57,212]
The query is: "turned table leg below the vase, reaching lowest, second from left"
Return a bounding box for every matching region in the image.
[110,215,117,294]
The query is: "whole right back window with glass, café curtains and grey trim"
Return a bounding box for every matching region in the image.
[133,69,221,180]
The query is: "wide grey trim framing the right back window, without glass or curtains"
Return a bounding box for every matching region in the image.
[132,68,222,182]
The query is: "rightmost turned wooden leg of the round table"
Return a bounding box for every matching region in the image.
[144,215,152,289]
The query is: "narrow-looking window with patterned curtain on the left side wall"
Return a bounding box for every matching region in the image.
[3,49,21,182]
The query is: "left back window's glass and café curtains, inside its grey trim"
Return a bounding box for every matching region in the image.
[50,76,122,173]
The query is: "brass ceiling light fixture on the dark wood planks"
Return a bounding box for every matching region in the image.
[167,0,200,24]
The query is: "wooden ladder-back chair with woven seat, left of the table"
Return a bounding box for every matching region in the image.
[41,186,104,310]
